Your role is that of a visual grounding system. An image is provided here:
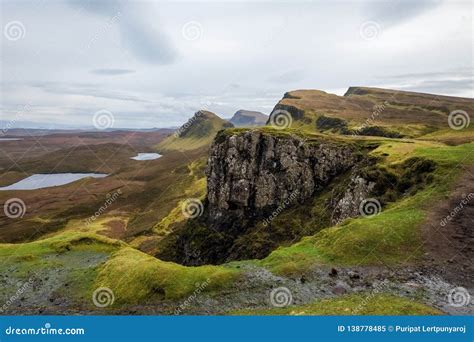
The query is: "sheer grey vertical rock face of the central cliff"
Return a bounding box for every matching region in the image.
[206,130,361,231]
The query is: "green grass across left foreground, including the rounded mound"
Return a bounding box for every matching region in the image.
[0,231,239,307]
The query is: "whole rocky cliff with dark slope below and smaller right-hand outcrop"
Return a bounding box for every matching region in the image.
[157,127,434,265]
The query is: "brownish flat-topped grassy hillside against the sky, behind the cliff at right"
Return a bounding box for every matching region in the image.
[275,87,474,142]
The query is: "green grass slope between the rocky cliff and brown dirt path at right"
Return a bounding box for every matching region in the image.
[255,143,474,275]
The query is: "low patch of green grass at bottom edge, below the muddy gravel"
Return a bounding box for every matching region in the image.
[232,294,442,316]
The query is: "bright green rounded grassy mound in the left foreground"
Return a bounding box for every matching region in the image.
[96,248,239,304]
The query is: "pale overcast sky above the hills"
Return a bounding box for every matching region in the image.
[0,0,474,128]
